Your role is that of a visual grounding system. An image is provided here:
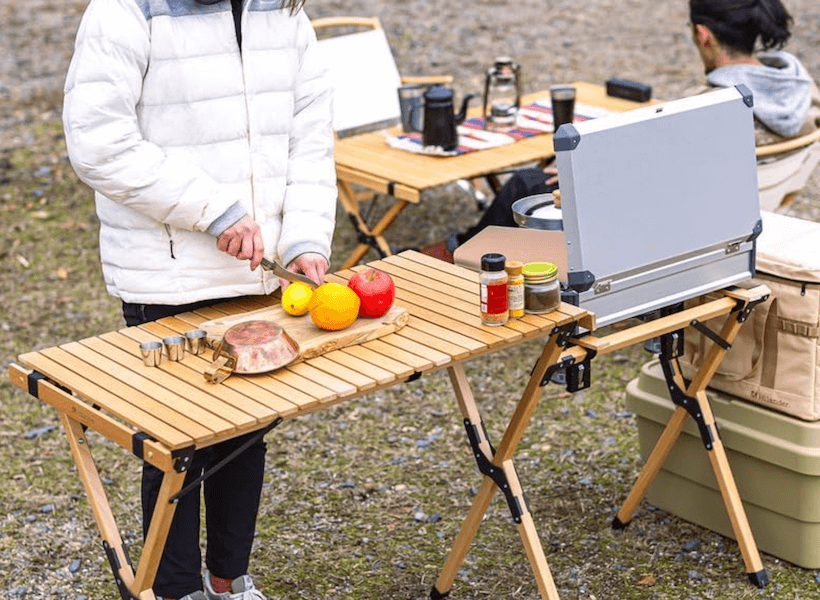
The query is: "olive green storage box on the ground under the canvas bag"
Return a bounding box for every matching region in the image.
[626,360,820,569]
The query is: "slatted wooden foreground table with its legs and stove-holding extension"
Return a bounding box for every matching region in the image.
[9,251,767,600]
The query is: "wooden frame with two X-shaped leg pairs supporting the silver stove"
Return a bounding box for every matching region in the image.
[430,286,769,600]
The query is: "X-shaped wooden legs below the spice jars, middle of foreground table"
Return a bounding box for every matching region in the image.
[430,329,566,600]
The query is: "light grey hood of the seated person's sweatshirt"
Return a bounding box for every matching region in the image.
[706,50,812,137]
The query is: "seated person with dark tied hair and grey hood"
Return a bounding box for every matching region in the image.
[447,0,820,253]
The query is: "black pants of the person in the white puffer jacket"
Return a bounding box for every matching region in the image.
[123,300,267,598]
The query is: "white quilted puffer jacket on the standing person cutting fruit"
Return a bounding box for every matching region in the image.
[63,0,336,305]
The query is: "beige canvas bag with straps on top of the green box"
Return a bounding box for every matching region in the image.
[680,211,820,421]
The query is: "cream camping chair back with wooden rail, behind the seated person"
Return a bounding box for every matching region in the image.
[755,129,820,211]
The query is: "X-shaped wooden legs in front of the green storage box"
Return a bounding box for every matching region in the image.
[613,311,768,587]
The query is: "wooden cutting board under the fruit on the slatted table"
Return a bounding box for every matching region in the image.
[200,304,410,359]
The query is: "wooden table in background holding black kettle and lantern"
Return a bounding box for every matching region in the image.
[334,81,642,268]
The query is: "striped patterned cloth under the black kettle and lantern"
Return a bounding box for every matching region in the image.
[387,98,611,156]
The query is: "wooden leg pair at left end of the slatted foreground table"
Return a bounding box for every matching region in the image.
[60,413,185,600]
